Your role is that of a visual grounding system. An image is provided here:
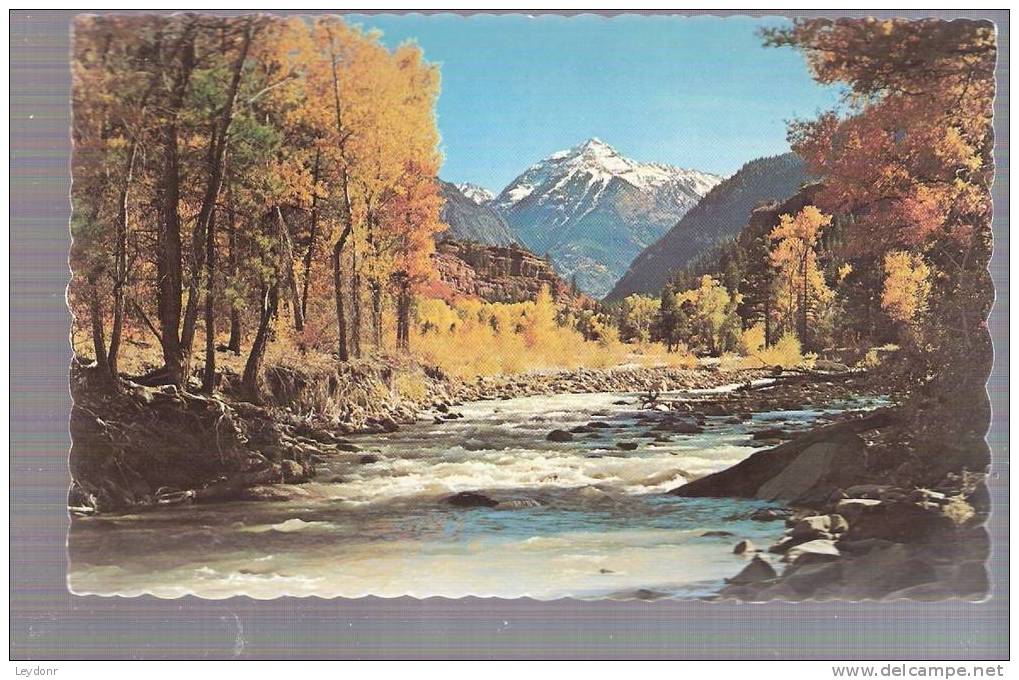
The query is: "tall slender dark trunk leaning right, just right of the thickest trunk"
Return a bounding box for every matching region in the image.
[180,20,252,354]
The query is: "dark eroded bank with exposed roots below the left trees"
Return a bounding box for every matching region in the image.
[68,365,314,515]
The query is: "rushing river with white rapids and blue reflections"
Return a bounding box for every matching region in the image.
[68,387,888,599]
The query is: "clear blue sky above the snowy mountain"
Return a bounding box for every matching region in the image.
[347,14,839,193]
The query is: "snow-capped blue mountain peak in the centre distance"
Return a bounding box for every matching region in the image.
[492,138,722,296]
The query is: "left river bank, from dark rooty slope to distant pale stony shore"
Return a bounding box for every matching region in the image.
[68,362,764,514]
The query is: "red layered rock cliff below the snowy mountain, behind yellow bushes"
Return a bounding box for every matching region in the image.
[434,241,578,303]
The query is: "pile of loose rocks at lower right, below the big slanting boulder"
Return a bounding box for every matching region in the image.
[719,485,989,601]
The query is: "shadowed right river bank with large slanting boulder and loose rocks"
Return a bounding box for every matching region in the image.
[671,377,990,601]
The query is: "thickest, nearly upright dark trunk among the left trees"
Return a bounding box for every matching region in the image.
[156,21,196,386]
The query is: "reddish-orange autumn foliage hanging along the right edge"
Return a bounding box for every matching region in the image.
[765,18,997,383]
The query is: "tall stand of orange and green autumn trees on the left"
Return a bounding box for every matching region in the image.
[70,14,444,398]
